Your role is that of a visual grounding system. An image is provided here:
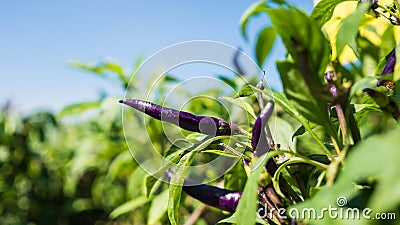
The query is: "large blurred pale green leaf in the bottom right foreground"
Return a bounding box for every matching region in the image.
[289,126,400,225]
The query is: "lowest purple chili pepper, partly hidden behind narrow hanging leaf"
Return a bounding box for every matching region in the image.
[165,170,242,212]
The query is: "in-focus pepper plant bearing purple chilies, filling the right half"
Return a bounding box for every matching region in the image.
[120,0,400,224]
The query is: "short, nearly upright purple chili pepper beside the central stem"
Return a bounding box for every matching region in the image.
[251,101,274,156]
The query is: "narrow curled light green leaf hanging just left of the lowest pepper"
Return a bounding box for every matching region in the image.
[168,151,197,225]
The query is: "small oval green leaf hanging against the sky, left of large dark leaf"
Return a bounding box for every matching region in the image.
[255,27,276,68]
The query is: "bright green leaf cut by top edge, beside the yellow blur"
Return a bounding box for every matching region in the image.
[310,0,355,27]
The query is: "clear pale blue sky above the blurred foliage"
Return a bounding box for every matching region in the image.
[0,0,312,112]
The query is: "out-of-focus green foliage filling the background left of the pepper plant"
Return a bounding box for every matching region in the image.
[0,57,242,225]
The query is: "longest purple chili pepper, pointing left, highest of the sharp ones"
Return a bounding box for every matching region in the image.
[119,99,240,136]
